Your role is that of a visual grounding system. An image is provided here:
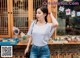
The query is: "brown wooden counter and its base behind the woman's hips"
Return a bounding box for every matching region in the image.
[0,40,80,58]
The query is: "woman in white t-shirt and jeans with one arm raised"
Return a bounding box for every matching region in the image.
[25,6,58,58]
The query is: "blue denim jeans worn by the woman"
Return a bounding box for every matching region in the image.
[30,45,50,58]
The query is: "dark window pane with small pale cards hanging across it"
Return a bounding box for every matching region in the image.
[57,0,80,35]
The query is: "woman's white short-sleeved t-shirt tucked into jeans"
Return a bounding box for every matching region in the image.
[27,21,55,46]
